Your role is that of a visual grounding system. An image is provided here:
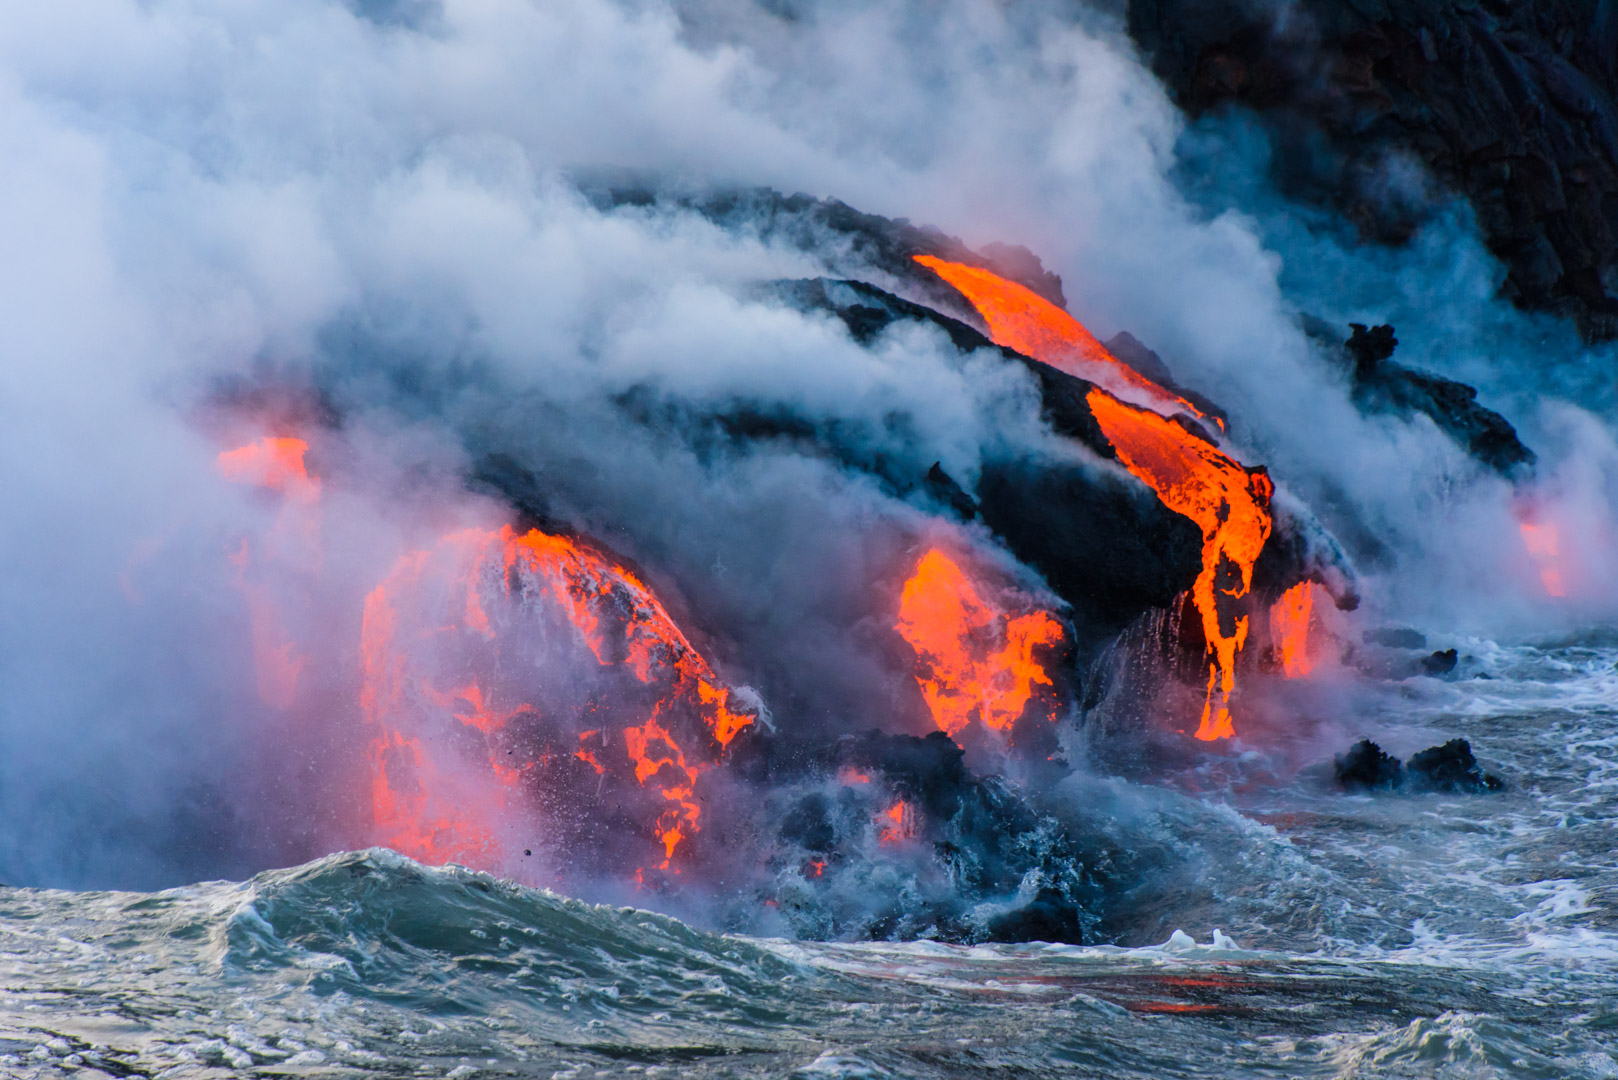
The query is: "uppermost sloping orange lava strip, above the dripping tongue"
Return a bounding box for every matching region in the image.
[914,254,1207,419]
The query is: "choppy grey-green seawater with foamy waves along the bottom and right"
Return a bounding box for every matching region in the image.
[0,638,1618,1080]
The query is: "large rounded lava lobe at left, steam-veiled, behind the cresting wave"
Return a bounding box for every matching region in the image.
[361,526,756,873]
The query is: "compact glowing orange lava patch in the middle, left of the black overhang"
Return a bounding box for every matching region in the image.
[895,549,1061,737]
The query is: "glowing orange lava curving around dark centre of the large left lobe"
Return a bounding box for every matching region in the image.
[361,526,756,870]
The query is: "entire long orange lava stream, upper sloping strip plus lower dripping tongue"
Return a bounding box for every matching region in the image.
[916,256,1275,740]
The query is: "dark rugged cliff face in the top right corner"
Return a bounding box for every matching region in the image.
[1129,0,1618,338]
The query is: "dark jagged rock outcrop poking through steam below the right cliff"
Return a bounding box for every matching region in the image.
[1343,322,1535,476]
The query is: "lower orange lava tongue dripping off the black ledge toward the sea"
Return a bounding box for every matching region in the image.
[1087,389,1275,740]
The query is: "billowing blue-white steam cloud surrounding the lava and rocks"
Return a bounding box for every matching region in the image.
[0,0,1618,933]
